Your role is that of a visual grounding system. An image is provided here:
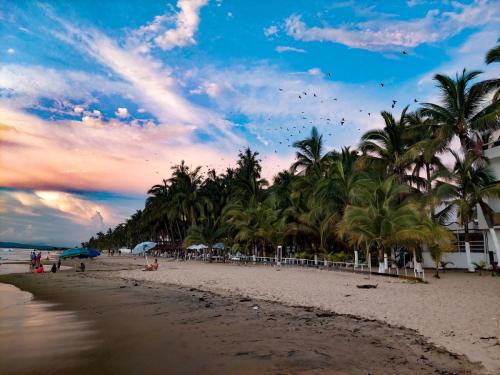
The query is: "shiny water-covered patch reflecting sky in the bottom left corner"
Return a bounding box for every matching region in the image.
[0,283,96,374]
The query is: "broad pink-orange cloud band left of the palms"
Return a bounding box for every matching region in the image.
[0,106,243,194]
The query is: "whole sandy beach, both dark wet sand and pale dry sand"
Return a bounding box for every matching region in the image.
[0,257,499,375]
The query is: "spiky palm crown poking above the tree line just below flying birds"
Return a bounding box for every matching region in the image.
[290,126,328,175]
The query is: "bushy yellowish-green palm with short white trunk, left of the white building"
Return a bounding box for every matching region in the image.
[337,176,418,273]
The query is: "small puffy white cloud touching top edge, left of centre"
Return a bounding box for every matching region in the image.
[155,0,208,50]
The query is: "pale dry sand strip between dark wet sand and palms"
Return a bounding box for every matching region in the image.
[110,262,500,374]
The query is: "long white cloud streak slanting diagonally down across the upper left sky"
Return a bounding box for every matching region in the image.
[47,15,242,144]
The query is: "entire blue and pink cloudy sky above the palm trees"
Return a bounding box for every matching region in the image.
[0,0,500,246]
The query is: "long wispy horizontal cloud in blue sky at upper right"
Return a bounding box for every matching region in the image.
[285,0,500,51]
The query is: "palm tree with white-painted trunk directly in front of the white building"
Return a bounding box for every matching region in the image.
[438,150,500,272]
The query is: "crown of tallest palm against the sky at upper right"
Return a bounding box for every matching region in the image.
[421,69,500,152]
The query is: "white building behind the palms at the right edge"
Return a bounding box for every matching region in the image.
[422,140,500,268]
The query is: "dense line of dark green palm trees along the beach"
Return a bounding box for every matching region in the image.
[85,42,500,278]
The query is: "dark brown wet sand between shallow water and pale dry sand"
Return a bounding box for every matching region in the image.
[0,263,483,375]
